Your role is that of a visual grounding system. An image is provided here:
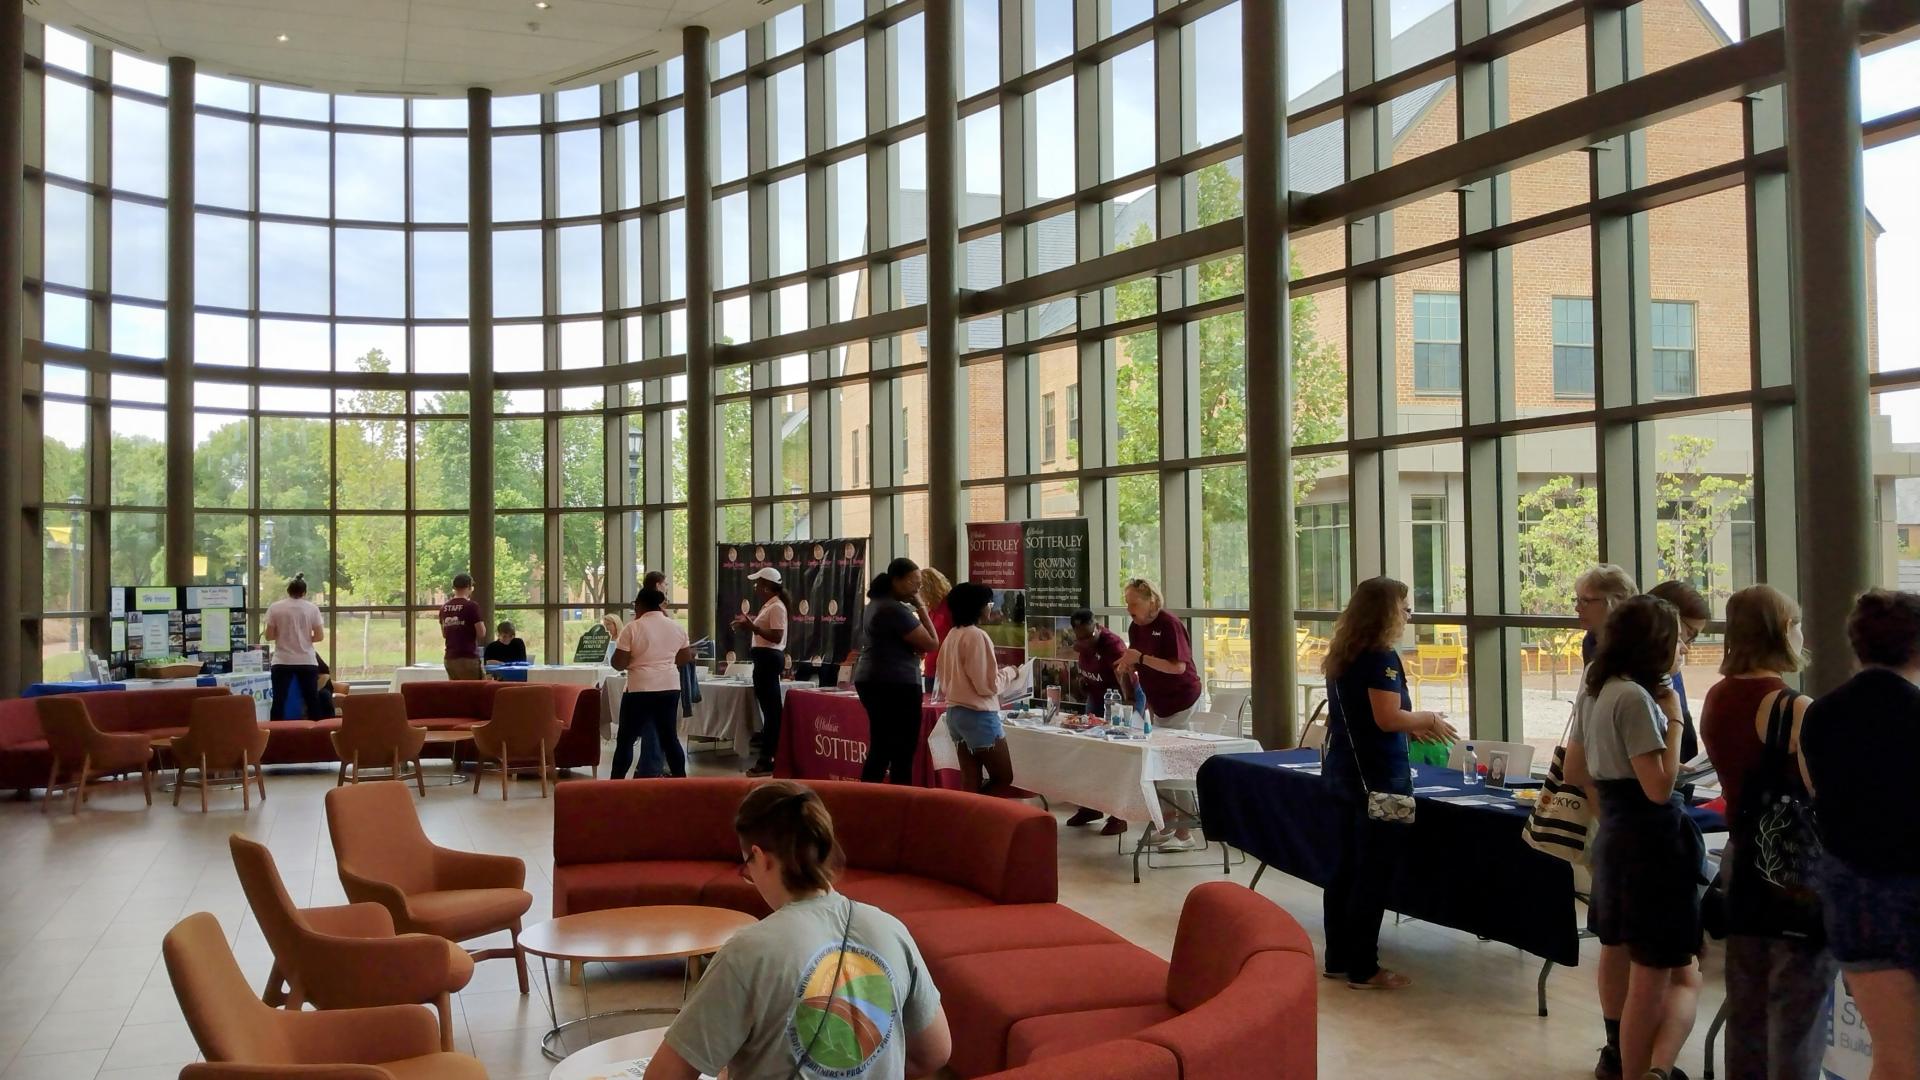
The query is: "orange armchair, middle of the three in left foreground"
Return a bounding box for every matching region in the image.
[227,832,474,1049]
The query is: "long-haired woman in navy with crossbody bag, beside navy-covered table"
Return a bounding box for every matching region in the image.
[1321,577,1455,990]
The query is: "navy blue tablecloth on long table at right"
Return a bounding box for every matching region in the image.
[1198,749,1726,967]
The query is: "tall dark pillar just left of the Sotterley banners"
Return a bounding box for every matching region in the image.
[924,0,966,575]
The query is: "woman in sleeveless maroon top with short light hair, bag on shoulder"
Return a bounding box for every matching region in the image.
[1699,584,1836,1080]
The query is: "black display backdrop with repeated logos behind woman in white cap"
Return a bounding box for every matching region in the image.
[714,538,868,665]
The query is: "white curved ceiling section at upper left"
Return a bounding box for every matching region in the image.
[27,0,791,96]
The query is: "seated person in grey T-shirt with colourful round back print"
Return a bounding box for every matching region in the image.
[645,780,952,1080]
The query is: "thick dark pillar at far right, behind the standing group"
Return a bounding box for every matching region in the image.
[1786,0,1878,694]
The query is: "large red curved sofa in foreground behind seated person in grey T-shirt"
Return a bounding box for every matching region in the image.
[553,778,1317,1080]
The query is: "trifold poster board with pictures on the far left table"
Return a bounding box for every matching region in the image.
[108,584,248,678]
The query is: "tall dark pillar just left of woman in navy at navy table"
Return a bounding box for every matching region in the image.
[1240,0,1296,748]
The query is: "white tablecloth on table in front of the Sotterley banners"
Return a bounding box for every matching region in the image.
[983,721,1260,826]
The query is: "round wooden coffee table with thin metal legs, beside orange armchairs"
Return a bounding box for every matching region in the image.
[520,905,756,1061]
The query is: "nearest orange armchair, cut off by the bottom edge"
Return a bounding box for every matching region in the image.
[161,911,486,1080]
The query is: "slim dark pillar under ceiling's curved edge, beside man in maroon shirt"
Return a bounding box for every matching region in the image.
[464,86,495,611]
